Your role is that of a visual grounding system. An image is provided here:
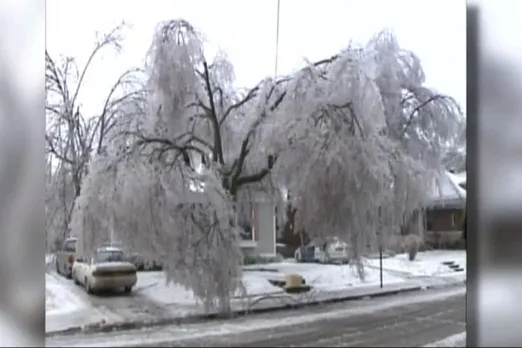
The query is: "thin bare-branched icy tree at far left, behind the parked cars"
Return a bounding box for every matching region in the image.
[45,25,142,245]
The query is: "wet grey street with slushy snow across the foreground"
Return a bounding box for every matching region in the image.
[46,288,466,347]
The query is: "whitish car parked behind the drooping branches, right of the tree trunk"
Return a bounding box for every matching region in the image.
[294,238,350,263]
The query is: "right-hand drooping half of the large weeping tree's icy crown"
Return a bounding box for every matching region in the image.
[265,31,463,276]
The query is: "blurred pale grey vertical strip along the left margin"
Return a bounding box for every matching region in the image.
[0,0,45,347]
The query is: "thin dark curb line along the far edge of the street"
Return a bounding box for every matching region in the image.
[45,281,460,337]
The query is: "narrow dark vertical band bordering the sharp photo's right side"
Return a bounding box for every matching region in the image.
[466,4,481,347]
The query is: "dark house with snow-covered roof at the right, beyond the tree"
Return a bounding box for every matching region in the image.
[424,171,466,248]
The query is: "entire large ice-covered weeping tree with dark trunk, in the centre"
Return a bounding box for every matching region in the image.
[71,20,461,311]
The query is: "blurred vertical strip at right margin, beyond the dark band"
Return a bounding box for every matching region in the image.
[478,1,522,347]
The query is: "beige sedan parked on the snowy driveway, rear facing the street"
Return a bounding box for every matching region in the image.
[72,247,138,293]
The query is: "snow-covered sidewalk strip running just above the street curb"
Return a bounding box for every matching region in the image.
[46,275,465,337]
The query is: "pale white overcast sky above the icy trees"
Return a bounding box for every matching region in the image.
[46,0,466,118]
